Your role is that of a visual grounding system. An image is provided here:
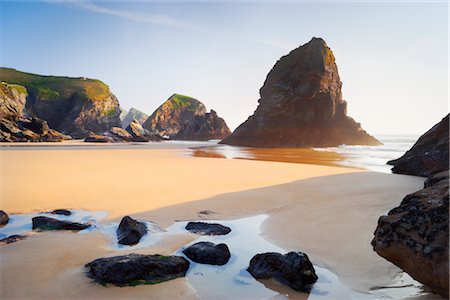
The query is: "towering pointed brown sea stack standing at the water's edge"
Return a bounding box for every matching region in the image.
[222,38,380,148]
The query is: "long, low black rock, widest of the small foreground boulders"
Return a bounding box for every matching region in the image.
[86,253,189,286]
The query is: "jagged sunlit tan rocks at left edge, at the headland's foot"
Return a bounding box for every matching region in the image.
[0,82,70,142]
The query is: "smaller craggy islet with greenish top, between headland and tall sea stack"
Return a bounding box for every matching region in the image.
[143,94,230,140]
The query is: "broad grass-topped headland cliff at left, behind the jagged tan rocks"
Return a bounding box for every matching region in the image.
[0,68,121,138]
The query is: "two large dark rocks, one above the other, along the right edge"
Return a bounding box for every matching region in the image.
[372,115,449,298]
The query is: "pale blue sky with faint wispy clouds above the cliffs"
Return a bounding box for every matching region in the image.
[0,0,449,134]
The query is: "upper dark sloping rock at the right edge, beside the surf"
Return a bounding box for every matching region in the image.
[388,114,449,177]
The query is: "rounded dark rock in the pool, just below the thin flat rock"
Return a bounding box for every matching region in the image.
[183,242,231,266]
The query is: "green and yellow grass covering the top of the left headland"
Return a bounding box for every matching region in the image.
[0,68,109,101]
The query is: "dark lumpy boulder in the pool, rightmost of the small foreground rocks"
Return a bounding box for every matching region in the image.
[247,252,317,293]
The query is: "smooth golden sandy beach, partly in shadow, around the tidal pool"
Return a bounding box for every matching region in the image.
[0,147,431,299]
